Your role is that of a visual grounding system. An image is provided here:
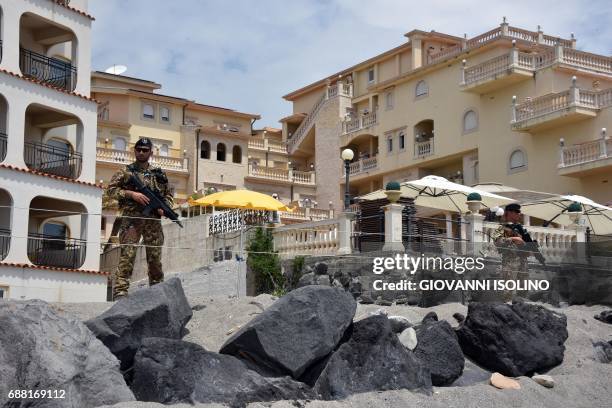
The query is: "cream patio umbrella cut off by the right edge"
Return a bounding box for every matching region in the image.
[521,195,612,235]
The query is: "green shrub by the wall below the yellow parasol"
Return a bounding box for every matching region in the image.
[246,227,285,296]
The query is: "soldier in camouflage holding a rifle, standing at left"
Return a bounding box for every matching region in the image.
[107,138,173,299]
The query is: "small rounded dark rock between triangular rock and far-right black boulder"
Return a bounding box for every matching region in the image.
[414,320,465,386]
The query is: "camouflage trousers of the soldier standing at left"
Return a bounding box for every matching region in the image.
[113,218,164,297]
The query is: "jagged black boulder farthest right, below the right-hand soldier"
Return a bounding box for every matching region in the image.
[457,302,568,377]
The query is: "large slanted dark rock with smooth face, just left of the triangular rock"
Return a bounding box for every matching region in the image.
[220,285,357,379]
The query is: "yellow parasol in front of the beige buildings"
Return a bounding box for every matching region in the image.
[193,190,292,211]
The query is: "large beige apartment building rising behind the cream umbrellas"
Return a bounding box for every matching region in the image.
[281,18,612,208]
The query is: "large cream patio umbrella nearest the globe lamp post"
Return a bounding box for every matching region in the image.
[360,176,514,213]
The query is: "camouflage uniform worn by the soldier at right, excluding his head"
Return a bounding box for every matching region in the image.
[491,225,529,302]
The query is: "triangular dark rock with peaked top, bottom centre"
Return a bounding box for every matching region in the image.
[315,315,431,400]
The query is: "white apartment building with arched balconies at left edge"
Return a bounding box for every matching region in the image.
[0,0,107,302]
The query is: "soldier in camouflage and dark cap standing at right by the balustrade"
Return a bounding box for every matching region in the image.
[491,204,529,302]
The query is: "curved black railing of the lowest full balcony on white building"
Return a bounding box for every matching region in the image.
[28,233,87,269]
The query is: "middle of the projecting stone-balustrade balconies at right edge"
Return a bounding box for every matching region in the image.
[511,83,612,132]
